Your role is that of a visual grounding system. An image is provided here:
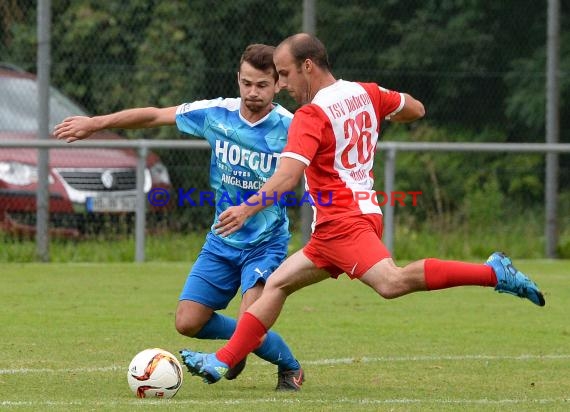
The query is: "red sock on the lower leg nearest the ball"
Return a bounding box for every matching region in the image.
[216,312,267,368]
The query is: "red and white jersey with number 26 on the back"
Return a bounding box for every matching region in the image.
[281,80,405,229]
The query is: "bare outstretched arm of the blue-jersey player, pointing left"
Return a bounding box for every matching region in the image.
[53,106,177,143]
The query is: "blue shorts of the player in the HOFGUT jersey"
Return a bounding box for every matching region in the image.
[180,232,289,310]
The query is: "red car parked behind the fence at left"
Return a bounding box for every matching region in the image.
[0,64,171,236]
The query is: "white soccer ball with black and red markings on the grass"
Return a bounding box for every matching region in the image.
[127,348,183,398]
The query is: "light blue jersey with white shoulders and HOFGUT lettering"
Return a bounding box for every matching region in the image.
[176,98,293,249]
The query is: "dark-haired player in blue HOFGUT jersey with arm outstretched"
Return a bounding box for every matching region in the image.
[54,44,304,390]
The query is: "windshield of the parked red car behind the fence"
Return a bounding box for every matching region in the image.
[0,77,86,133]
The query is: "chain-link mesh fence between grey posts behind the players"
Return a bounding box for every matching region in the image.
[0,0,570,258]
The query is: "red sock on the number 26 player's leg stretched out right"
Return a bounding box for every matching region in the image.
[424,259,497,290]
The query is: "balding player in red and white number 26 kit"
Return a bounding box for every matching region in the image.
[181,33,545,385]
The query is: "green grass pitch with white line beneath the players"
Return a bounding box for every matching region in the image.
[0,260,570,412]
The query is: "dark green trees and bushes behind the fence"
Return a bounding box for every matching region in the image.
[0,0,570,256]
